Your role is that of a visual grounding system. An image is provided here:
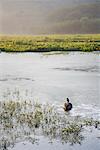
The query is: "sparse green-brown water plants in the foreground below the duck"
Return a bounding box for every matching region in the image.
[0,101,100,150]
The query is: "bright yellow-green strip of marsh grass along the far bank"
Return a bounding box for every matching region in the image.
[0,34,100,52]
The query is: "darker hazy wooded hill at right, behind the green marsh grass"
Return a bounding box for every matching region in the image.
[47,3,100,33]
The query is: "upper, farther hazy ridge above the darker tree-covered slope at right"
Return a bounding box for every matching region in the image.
[48,3,100,22]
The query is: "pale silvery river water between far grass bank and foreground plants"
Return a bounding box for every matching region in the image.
[0,52,100,150]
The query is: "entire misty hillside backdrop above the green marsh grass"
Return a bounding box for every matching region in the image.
[0,0,100,34]
